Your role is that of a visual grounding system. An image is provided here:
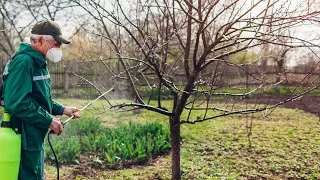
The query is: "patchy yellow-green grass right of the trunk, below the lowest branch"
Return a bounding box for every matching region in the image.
[182,109,320,179]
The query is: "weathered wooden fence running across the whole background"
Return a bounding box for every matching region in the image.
[0,58,320,98]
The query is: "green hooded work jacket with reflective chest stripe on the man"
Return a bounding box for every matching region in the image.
[2,43,64,151]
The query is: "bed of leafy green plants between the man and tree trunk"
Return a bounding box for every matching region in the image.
[46,118,171,164]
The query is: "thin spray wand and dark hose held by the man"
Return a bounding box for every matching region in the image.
[48,88,114,180]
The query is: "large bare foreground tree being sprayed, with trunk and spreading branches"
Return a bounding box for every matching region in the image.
[68,0,319,179]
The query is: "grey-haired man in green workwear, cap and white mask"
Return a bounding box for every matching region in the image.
[2,20,80,180]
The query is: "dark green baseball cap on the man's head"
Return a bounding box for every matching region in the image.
[31,20,70,44]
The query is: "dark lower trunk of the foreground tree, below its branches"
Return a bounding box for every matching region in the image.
[170,116,181,180]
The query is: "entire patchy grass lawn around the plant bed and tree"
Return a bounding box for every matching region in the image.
[45,99,320,179]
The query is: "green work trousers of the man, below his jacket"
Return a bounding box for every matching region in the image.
[18,149,43,180]
